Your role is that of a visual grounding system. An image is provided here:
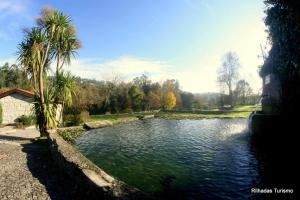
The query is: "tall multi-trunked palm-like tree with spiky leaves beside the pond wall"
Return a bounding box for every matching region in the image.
[18,8,81,136]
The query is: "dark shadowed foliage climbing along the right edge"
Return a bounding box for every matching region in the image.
[260,0,300,115]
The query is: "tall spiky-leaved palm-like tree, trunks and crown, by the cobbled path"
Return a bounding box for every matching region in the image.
[18,8,80,136]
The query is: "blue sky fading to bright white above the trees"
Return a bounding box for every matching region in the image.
[0,0,267,93]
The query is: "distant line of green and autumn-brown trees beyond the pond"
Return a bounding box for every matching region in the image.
[0,63,258,117]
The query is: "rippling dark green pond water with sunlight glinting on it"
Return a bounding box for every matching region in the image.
[76,119,258,199]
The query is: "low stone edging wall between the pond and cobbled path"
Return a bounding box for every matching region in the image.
[49,130,151,199]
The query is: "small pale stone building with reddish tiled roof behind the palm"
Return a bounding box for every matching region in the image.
[0,88,61,124]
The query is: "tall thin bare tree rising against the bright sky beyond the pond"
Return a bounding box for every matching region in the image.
[217,52,240,107]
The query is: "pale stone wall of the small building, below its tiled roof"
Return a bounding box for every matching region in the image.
[0,93,33,124]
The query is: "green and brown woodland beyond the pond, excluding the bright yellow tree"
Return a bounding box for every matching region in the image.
[64,75,258,115]
